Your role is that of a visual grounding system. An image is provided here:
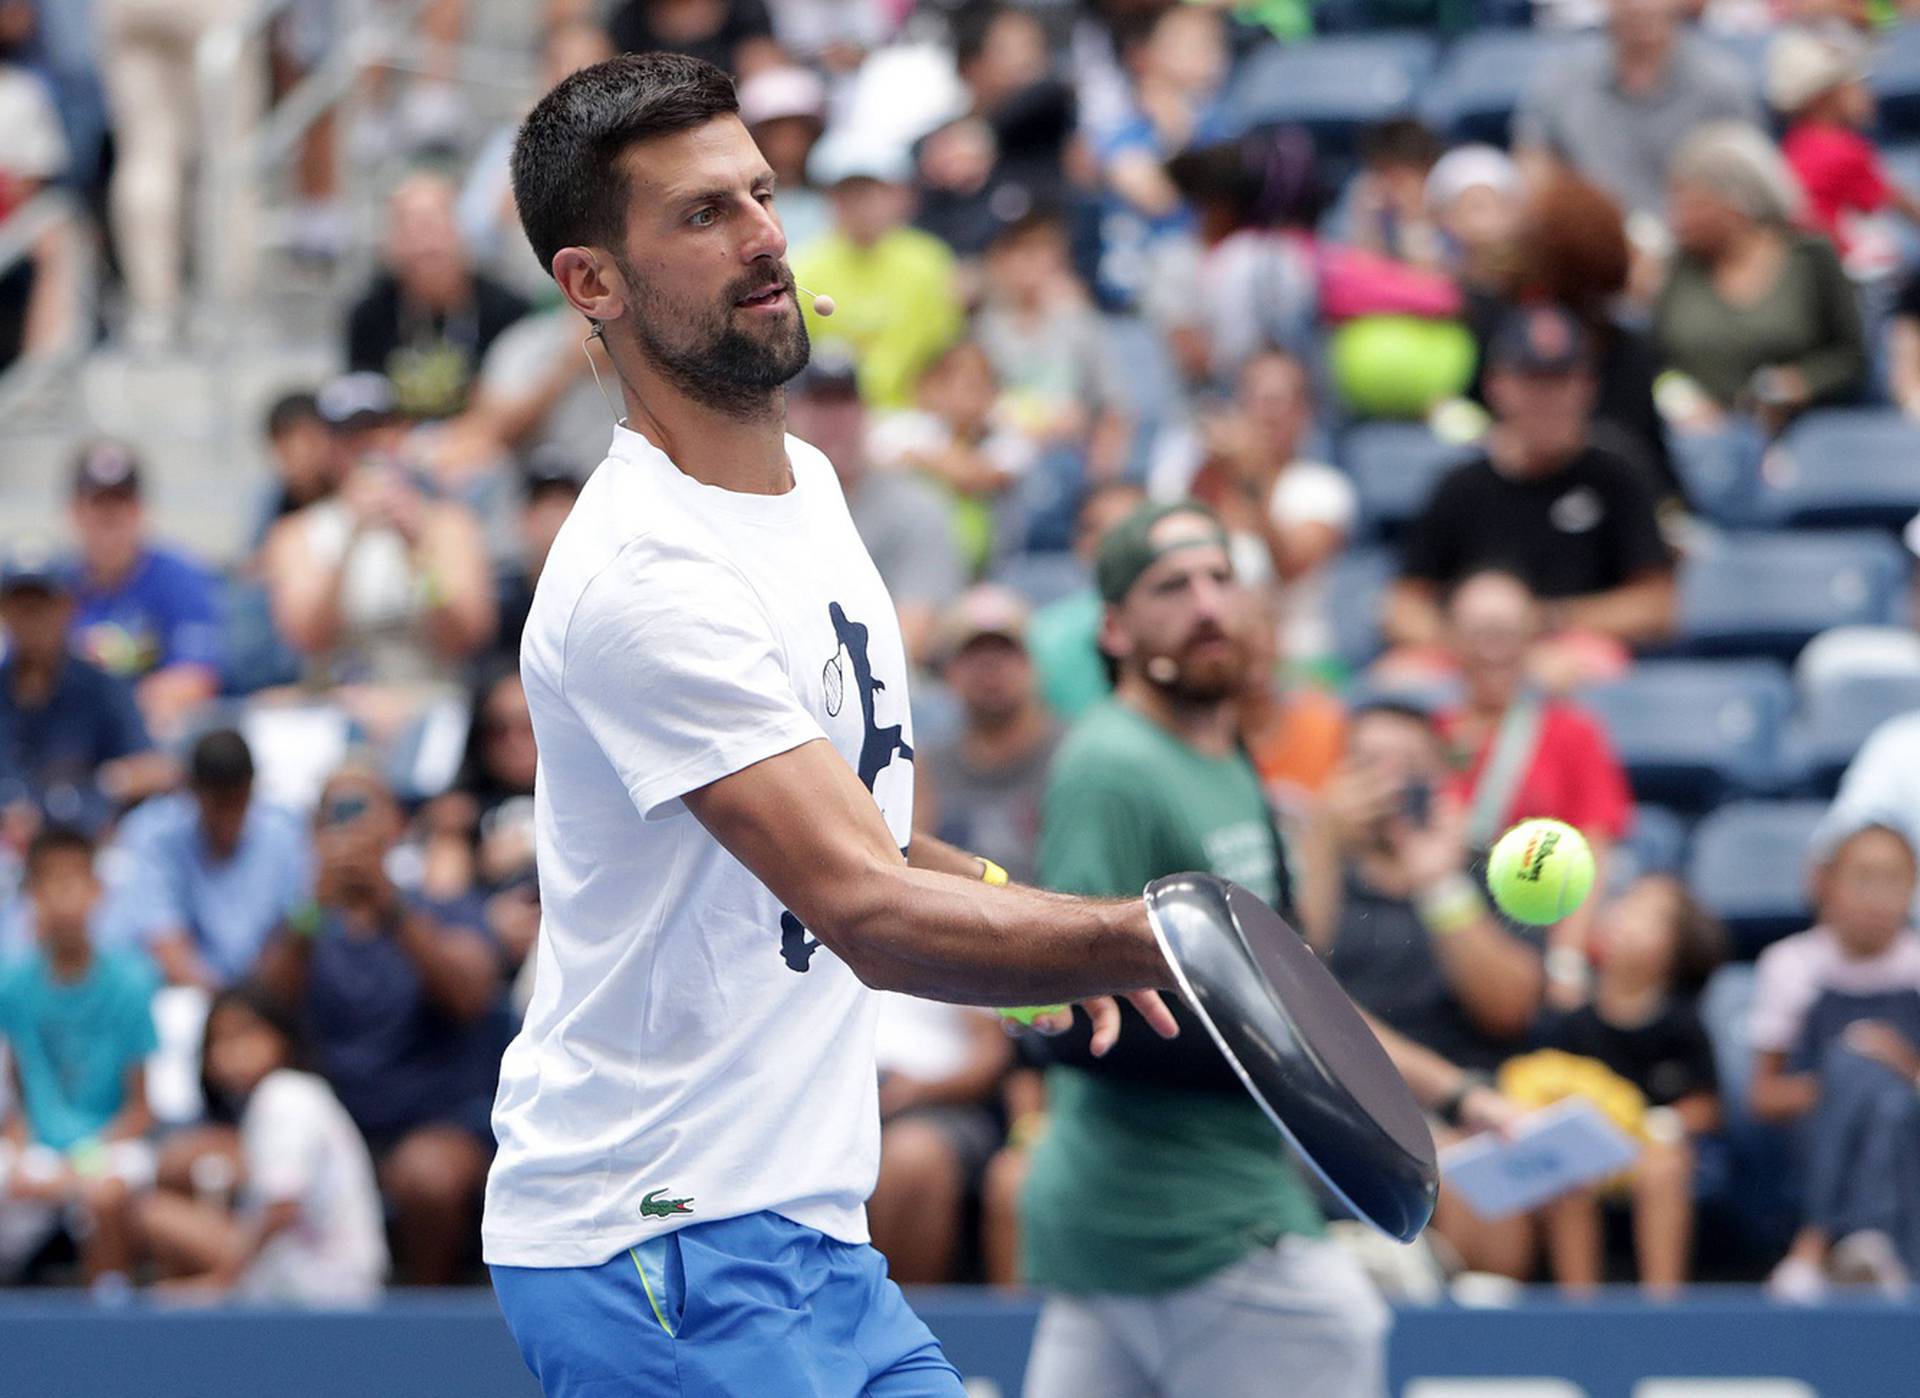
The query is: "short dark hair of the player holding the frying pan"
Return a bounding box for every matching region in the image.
[513,54,739,273]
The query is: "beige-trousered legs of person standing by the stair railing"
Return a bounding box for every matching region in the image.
[96,0,267,350]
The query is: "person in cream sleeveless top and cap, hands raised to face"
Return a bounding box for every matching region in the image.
[261,395,495,734]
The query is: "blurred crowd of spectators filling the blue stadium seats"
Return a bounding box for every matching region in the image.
[0,0,1920,1304]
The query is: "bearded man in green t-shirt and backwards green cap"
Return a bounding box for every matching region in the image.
[1021,503,1500,1398]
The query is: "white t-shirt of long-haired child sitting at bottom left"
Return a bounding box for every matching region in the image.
[240,1068,386,1306]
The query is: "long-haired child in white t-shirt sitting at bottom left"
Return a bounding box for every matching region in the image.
[134,985,386,1306]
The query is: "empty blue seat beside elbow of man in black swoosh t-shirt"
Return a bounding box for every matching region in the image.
[1680,532,1908,659]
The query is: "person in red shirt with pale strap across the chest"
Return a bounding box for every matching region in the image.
[1434,570,1634,1002]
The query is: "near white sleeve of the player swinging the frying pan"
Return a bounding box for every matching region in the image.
[561,536,826,820]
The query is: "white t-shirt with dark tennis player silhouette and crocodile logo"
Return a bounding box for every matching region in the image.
[482,428,914,1267]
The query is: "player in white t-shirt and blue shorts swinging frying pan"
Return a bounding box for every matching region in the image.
[484,54,1175,1398]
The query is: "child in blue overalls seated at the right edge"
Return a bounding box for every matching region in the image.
[1749,824,1920,1298]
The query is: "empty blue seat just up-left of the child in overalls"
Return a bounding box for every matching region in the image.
[1688,801,1826,956]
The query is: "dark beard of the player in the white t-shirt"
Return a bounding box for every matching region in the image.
[620,259,812,419]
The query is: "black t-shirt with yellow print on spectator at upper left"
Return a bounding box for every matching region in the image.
[348,273,530,421]
